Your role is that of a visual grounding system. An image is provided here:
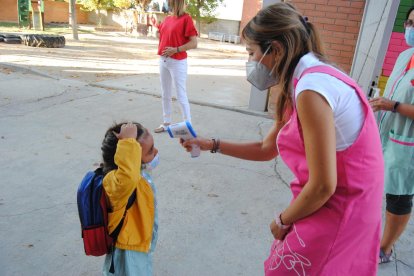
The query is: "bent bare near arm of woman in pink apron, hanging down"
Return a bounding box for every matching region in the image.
[281,90,337,224]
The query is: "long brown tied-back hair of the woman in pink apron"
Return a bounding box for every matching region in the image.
[242,3,327,123]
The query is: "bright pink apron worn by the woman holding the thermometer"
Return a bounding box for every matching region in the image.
[264,66,384,276]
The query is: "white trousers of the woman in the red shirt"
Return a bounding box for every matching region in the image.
[160,57,191,123]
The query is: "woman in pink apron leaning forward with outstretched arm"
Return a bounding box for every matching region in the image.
[183,3,384,276]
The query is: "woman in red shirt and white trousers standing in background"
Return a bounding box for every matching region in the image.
[153,0,198,133]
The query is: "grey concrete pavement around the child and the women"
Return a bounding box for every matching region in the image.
[0,35,414,276]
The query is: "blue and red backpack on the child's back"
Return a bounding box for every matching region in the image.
[77,167,136,273]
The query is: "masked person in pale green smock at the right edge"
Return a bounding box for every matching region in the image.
[370,7,414,263]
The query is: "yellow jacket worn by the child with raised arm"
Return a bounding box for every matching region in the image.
[103,138,155,252]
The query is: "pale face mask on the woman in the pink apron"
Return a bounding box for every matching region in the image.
[246,45,279,90]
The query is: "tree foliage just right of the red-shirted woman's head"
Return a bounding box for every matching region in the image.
[186,0,223,32]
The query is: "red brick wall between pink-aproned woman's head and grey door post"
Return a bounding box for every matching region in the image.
[291,0,365,73]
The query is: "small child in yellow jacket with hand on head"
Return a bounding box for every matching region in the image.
[101,122,159,275]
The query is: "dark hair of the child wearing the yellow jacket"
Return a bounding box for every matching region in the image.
[101,122,148,174]
